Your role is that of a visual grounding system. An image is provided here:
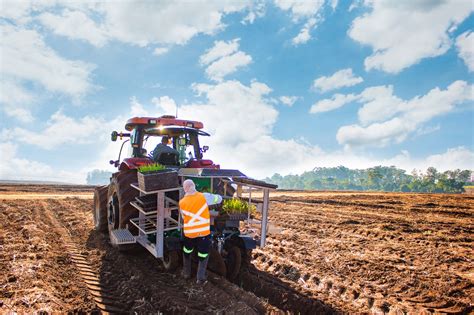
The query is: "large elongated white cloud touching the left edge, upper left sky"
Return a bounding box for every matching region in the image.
[0,25,93,97]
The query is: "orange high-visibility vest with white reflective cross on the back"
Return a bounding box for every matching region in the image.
[179,192,211,238]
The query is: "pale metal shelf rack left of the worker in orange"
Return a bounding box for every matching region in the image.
[130,184,183,258]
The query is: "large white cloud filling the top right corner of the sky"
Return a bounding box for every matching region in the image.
[349,0,473,73]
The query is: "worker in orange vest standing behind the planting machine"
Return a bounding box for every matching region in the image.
[179,179,222,284]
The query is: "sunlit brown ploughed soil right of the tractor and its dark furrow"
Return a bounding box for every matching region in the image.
[253,193,474,314]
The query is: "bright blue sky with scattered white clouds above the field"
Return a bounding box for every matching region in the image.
[0,0,474,183]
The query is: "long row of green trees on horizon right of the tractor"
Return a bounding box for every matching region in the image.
[265,166,471,193]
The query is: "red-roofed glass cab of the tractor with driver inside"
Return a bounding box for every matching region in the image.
[110,116,219,170]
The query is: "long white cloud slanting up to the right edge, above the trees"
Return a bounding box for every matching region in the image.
[336,81,474,148]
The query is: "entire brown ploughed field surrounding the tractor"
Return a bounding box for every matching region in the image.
[0,186,474,314]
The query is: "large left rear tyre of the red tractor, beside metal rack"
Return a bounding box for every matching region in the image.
[107,170,138,250]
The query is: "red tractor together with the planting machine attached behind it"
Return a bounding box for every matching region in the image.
[93,116,276,279]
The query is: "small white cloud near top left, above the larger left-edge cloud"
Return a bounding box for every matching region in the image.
[38,10,108,47]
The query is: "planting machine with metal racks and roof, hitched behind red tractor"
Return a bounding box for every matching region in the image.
[107,169,276,280]
